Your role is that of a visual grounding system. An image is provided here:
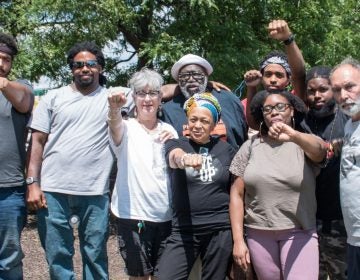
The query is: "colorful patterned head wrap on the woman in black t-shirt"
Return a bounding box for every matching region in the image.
[184,92,221,123]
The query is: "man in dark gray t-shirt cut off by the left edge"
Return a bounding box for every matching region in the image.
[0,33,34,279]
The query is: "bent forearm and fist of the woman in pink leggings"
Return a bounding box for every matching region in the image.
[268,123,327,162]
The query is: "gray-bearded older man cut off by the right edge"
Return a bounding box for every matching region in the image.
[330,58,360,280]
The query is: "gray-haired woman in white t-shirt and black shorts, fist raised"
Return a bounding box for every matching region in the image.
[108,69,177,279]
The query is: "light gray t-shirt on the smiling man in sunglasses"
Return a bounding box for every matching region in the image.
[30,86,113,195]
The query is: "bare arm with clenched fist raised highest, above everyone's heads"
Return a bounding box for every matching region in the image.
[268,20,306,101]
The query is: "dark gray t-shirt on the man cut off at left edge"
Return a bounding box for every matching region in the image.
[0,80,31,188]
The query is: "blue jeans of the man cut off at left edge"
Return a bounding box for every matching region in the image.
[0,186,26,280]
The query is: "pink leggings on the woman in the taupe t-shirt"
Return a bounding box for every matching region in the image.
[246,228,319,280]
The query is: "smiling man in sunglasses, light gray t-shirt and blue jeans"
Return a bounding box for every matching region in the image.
[27,42,113,279]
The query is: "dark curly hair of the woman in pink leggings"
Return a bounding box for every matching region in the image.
[250,90,307,134]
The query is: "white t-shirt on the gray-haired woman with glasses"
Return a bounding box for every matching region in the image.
[110,119,177,222]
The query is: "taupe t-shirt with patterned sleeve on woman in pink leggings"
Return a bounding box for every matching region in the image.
[230,138,316,230]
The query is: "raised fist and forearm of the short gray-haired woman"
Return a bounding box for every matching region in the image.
[107,92,126,146]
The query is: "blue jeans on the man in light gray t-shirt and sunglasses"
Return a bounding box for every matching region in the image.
[37,192,109,280]
